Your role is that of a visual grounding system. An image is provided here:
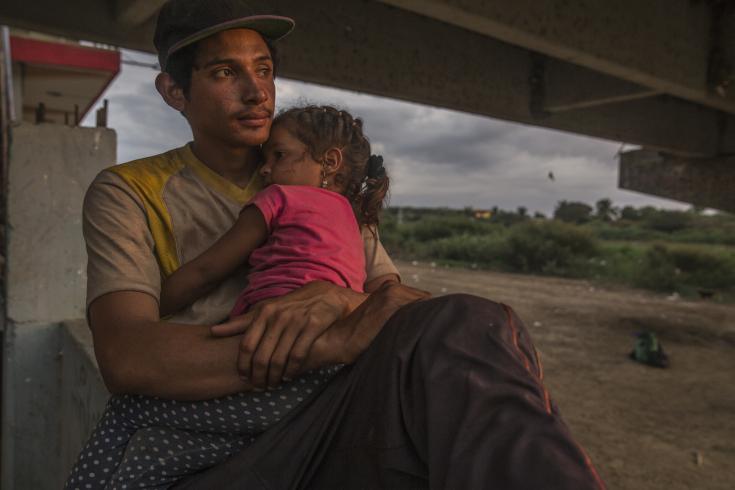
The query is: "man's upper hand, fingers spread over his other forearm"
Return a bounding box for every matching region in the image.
[211,282,367,389]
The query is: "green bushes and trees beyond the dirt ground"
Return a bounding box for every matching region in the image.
[380,199,735,301]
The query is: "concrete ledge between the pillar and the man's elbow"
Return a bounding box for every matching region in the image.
[57,320,110,488]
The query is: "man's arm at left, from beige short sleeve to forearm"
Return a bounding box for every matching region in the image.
[83,171,258,400]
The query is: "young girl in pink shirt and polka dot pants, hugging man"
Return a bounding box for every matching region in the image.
[65,106,388,489]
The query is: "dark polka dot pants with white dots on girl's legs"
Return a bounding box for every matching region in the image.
[64,367,338,489]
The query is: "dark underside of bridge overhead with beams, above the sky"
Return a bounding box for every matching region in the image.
[0,0,735,211]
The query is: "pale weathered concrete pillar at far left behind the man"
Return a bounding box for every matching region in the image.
[2,124,116,490]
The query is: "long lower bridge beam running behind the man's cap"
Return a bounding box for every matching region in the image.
[0,0,735,157]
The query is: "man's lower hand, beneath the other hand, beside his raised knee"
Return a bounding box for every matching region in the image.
[304,282,431,370]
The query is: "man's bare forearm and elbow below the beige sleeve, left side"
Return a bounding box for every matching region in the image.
[89,291,252,400]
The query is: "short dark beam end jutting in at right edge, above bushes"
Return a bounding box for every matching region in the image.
[619,150,735,213]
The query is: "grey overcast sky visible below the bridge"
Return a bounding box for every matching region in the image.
[85,51,683,215]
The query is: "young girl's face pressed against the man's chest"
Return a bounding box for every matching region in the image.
[260,124,322,187]
